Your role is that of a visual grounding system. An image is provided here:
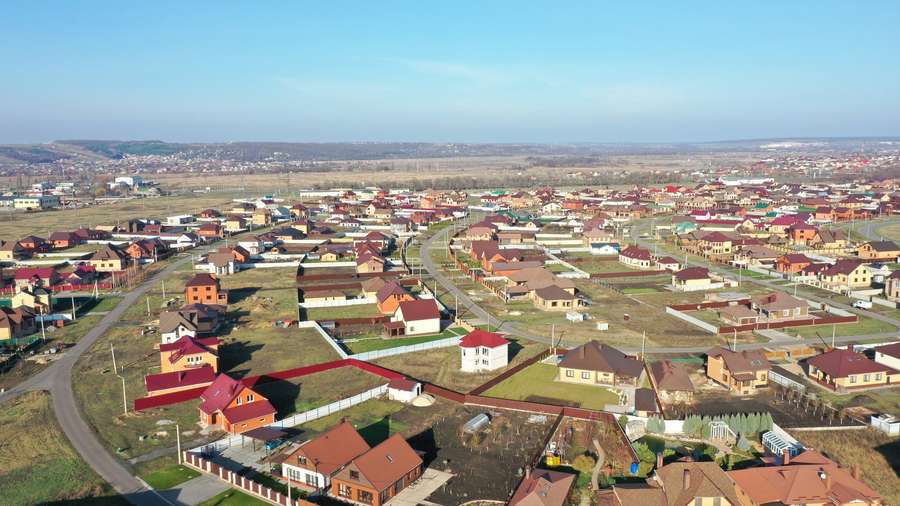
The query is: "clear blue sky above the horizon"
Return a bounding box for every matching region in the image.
[0,0,900,143]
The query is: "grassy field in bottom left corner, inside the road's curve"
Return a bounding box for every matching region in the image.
[0,392,128,505]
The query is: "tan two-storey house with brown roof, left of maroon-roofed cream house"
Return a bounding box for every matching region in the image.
[706,346,770,395]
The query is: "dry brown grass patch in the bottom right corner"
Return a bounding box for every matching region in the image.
[791,429,900,504]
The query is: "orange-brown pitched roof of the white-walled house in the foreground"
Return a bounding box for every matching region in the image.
[285,422,370,476]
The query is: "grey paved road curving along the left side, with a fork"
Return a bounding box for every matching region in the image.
[0,257,202,506]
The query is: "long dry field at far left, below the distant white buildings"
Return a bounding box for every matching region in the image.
[0,192,239,240]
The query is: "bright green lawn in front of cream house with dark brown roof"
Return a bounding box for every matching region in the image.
[485,364,619,409]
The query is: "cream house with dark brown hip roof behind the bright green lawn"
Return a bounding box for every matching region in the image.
[557,341,644,386]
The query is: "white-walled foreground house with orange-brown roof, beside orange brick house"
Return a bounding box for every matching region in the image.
[281,421,370,490]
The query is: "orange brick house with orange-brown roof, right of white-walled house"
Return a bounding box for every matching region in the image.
[331,434,423,506]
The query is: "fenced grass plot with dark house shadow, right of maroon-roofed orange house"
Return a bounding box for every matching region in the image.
[254,367,388,418]
